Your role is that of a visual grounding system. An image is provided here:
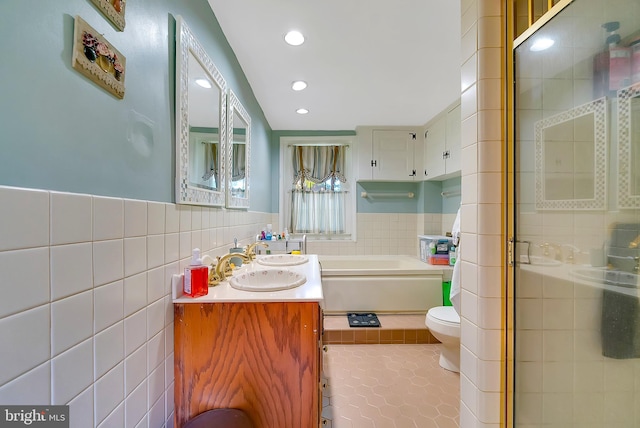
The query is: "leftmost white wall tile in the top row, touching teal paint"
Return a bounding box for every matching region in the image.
[0,186,49,251]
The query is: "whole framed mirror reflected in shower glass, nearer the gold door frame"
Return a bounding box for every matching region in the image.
[535,98,607,210]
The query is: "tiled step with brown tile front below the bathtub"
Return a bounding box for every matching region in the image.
[323,314,439,344]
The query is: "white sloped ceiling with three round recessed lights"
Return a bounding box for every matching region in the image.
[208,0,460,130]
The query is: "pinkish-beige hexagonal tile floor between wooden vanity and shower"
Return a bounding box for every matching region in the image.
[322,344,460,428]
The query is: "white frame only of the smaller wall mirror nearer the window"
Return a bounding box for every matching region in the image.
[225,89,251,208]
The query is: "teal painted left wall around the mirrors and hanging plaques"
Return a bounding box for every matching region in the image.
[0,0,272,212]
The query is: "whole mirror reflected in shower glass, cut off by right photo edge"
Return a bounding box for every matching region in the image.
[618,83,640,208]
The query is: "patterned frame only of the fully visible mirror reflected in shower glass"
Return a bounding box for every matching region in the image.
[535,97,607,210]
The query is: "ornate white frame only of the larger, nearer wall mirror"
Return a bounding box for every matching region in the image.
[176,16,227,206]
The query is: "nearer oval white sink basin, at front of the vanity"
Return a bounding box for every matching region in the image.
[229,269,307,291]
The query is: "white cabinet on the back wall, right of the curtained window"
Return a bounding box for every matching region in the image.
[357,127,424,181]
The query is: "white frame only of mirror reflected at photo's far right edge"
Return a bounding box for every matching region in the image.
[618,83,640,209]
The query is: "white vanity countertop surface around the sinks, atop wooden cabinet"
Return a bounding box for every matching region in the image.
[173,254,323,303]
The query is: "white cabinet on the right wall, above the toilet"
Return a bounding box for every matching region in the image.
[421,104,461,180]
